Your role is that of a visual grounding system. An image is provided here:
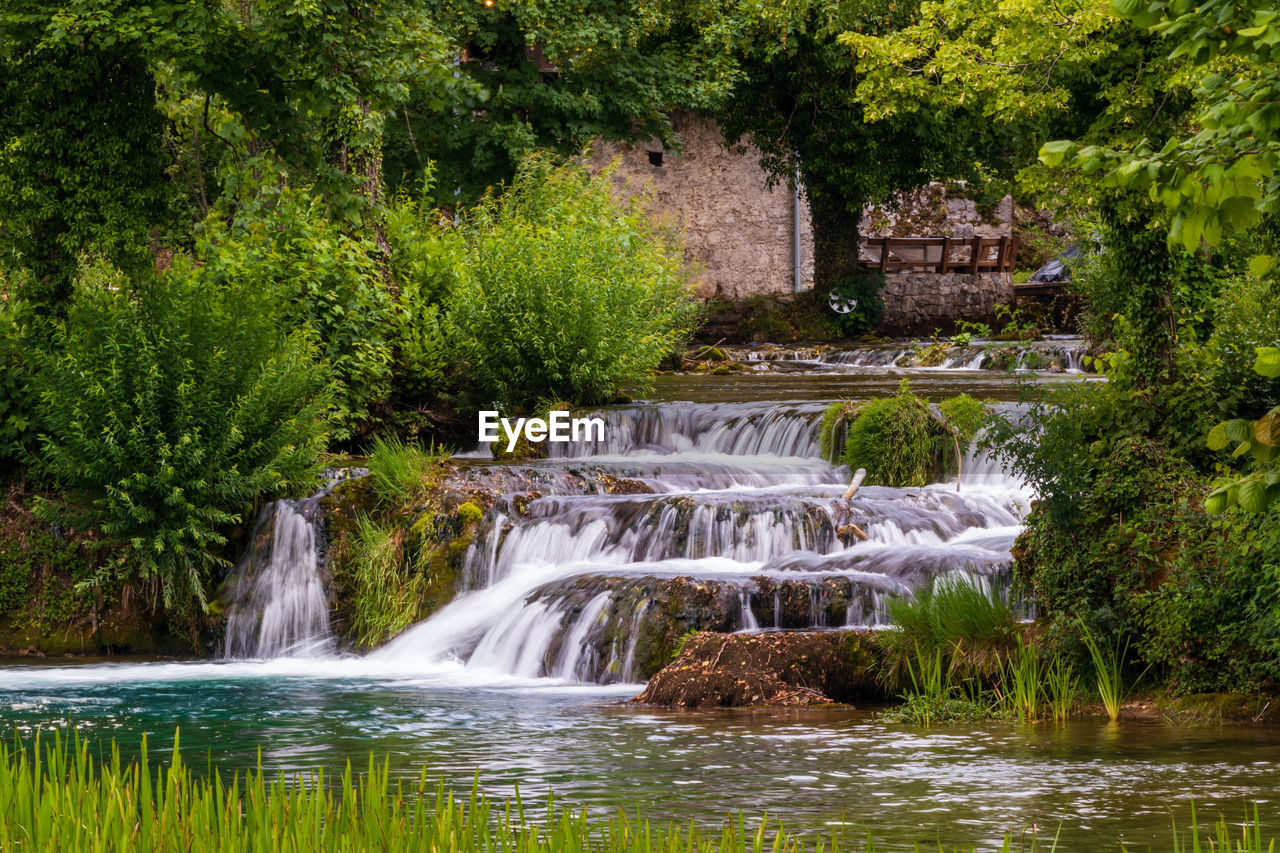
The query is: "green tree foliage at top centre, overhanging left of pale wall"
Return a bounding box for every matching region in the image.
[385,0,727,207]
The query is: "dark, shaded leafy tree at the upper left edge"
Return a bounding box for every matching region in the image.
[0,44,169,311]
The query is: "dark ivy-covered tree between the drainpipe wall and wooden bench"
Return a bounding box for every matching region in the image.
[703,0,973,288]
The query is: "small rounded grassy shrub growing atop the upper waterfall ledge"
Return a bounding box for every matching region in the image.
[844,379,951,487]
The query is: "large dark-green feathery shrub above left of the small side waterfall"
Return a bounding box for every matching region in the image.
[37,258,329,612]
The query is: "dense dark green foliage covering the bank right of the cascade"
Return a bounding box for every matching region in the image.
[989,258,1280,692]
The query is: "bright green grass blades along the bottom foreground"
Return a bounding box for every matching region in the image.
[0,735,1275,853]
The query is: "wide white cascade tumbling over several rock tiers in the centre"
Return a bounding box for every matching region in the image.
[374,402,1027,683]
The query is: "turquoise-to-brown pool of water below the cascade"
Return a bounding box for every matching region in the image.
[0,658,1280,850]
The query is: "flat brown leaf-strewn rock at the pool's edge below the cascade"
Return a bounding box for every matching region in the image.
[632,631,887,708]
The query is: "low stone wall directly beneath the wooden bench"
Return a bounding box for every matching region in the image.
[881,273,1014,334]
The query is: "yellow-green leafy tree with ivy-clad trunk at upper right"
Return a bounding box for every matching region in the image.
[841,0,1213,384]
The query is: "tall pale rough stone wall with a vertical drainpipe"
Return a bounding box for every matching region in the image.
[590,114,813,298]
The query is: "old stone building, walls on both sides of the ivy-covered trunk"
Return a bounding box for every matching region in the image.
[590,113,1012,328]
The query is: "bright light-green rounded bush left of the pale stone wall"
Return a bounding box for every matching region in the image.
[448,159,699,406]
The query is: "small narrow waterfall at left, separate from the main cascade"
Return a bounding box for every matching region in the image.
[223,493,334,658]
